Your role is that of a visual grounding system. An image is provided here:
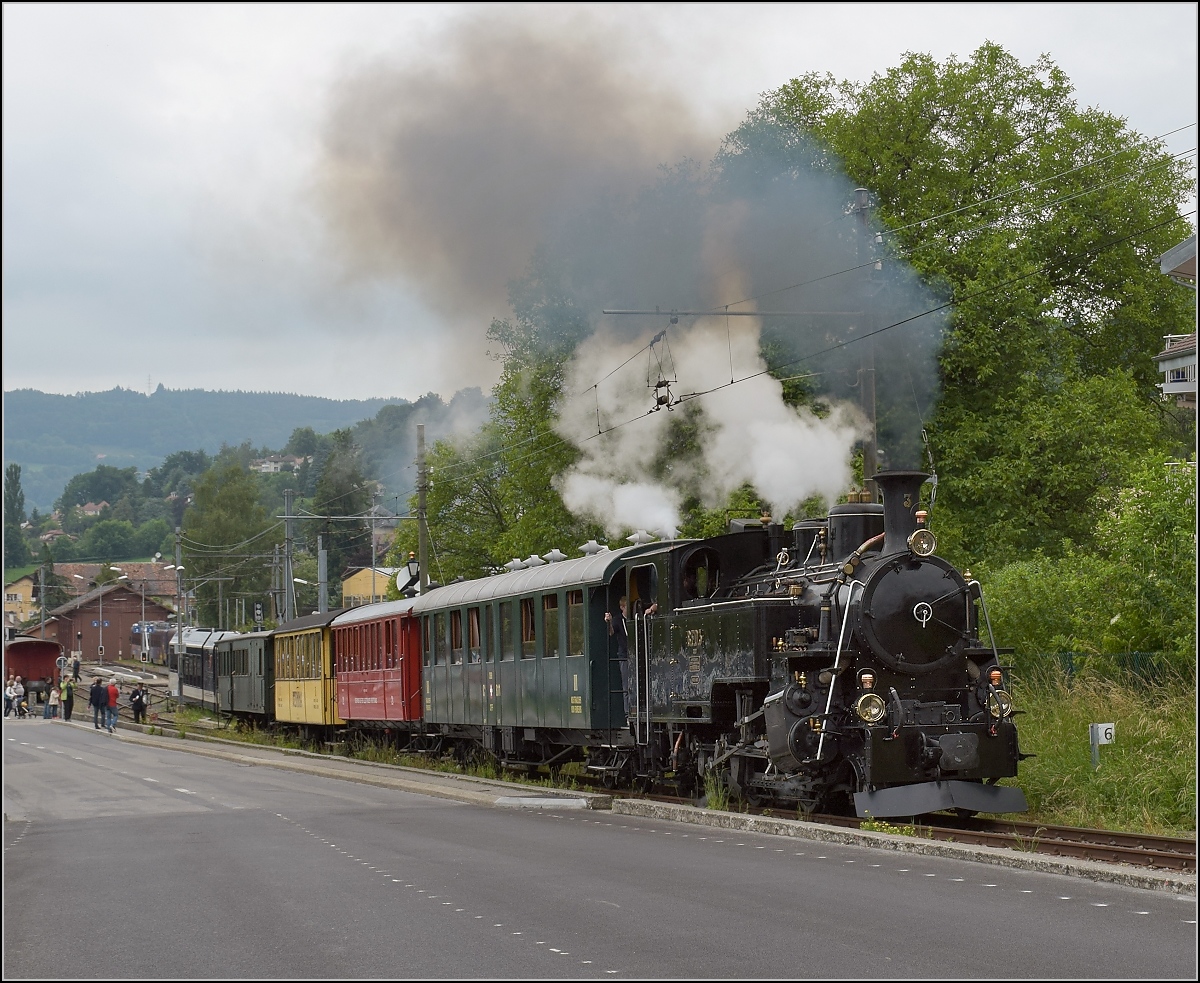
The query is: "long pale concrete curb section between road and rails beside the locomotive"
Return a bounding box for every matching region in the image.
[612,798,1196,898]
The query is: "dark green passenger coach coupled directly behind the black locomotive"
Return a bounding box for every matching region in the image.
[412,544,665,765]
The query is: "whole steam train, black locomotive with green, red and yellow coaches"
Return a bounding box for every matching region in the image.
[182,472,1027,817]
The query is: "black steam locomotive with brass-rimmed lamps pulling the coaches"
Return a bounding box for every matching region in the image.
[635,472,1027,817]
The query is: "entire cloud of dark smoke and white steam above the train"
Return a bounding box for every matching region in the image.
[320,9,942,528]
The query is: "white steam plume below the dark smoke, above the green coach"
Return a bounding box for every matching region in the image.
[559,318,862,534]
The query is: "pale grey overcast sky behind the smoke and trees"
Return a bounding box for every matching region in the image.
[2,4,1198,398]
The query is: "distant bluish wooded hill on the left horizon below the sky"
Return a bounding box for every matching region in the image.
[4,385,486,511]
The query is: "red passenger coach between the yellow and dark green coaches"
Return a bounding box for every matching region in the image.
[330,600,421,726]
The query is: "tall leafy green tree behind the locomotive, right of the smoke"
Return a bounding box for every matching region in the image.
[719,43,1195,561]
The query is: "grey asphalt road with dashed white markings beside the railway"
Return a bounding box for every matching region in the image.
[4,720,1196,979]
